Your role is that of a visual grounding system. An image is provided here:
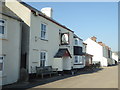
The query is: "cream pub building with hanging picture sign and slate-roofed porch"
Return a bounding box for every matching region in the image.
[6,0,74,74]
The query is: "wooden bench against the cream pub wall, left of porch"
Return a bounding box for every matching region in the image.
[36,66,58,78]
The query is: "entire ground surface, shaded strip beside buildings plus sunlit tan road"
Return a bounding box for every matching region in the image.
[3,66,118,90]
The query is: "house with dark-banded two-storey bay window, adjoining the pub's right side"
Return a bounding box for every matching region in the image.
[73,34,93,69]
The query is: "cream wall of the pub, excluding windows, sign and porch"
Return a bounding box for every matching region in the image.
[6,0,73,73]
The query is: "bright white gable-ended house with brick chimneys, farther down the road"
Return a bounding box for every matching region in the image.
[85,36,113,66]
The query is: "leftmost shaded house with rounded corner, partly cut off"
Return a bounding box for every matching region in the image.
[0,3,22,85]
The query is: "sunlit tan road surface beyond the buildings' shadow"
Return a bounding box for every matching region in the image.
[34,66,118,88]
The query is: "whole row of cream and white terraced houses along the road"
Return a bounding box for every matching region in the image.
[0,0,118,85]
